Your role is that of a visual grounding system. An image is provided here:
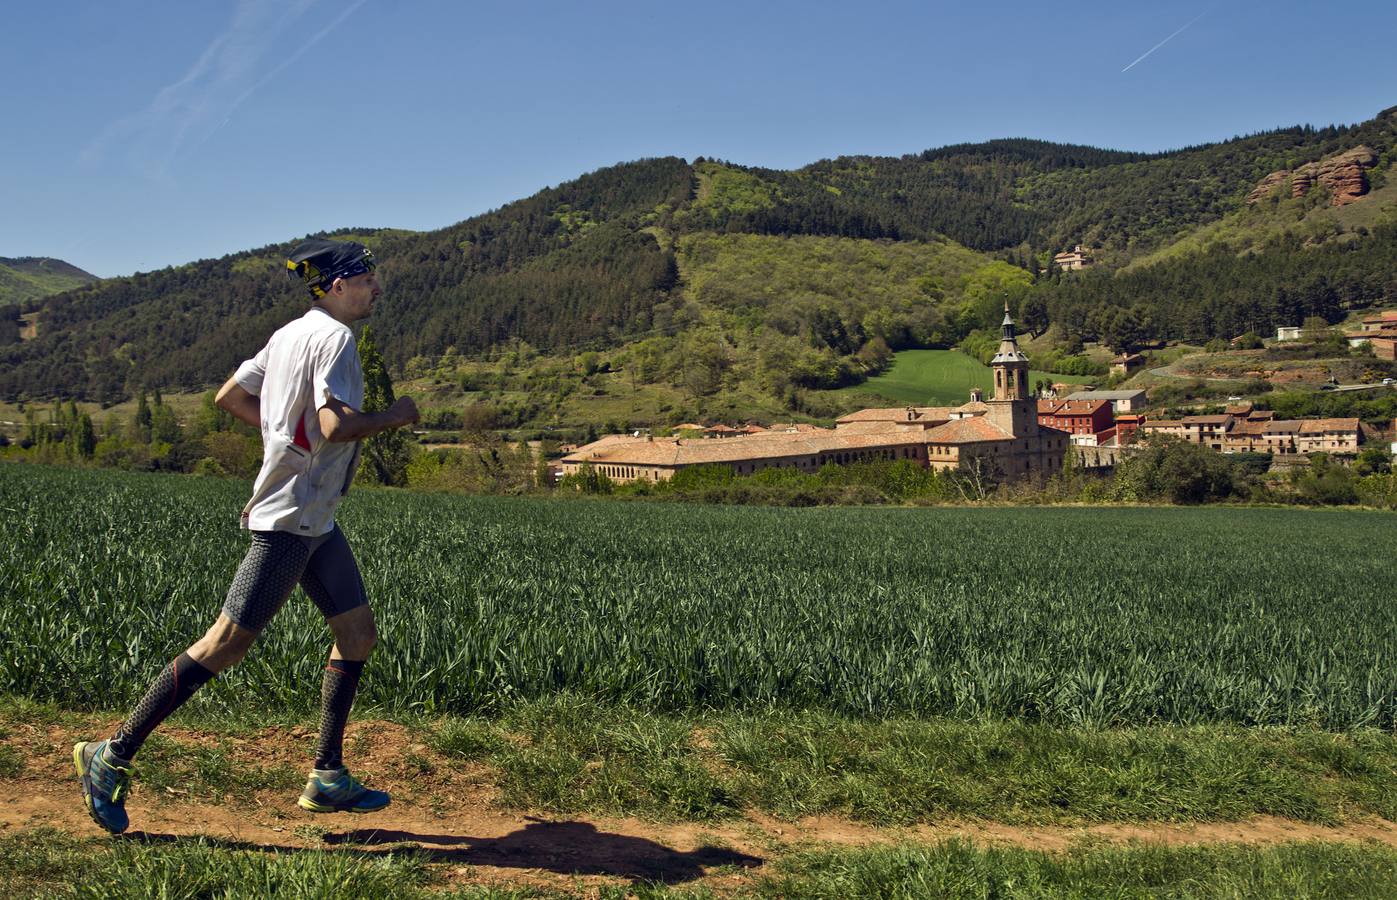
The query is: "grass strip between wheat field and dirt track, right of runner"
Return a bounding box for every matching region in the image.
[432,697,1397,825]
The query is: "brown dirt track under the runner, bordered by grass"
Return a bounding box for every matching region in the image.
[0,723,1397,893]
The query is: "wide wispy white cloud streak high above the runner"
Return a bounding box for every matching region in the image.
[81,0,367,180]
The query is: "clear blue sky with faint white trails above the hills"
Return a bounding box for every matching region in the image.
[0,0,1397,275]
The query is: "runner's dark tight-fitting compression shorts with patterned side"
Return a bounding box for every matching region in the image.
[224,525,369,632]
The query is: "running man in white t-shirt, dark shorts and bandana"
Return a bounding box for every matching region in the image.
[73,240,418,833]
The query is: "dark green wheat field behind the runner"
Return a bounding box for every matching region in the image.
[0,465,1397,730]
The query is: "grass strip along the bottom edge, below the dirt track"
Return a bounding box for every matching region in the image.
[8,830,1397,900]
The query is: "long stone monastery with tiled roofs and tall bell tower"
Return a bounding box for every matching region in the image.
[562,307,1070,482]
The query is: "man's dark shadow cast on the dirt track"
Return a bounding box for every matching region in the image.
[126,820,763,885]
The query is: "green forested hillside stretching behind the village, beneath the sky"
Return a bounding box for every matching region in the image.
[8,110,1397,401]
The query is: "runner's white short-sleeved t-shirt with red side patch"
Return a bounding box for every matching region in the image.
[233,306,363,537]
